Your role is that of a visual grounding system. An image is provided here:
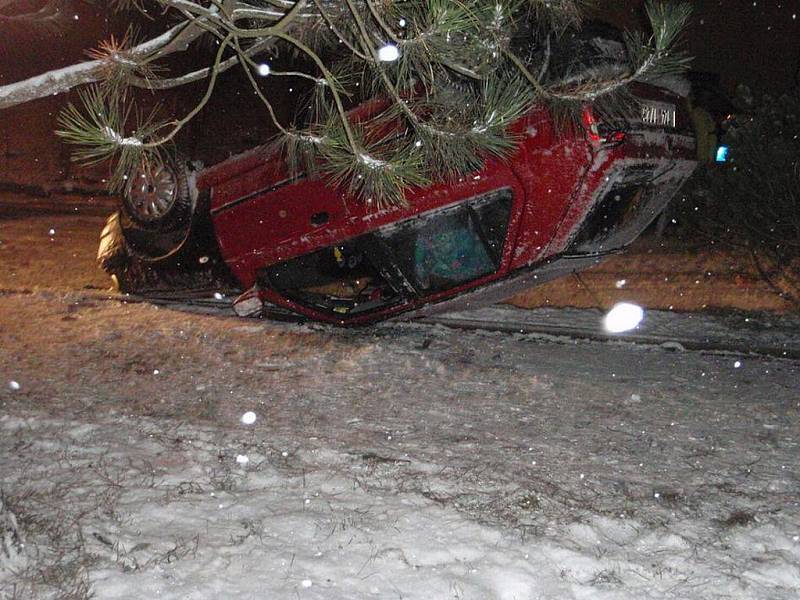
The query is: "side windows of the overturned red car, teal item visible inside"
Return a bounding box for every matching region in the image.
[262,188,513,318]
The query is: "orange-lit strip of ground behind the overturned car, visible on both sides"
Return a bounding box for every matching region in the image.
[0,194,790,312]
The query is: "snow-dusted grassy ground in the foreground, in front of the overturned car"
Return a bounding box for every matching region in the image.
[0,294,800,600]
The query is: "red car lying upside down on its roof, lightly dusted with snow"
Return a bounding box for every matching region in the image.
[99,79,696,325]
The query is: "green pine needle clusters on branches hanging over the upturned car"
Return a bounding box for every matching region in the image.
[59,0,690,208]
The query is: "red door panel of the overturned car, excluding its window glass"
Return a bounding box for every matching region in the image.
[212,155,526,287]
